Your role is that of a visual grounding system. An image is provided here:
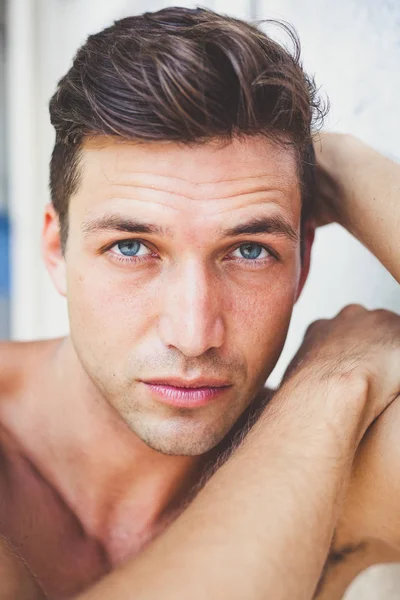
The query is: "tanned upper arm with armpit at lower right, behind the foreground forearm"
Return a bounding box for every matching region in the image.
[316,398,400,600]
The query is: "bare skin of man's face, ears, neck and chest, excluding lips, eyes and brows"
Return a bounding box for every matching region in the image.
[0,138,313,598]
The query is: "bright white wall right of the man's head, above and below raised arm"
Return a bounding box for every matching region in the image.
[253,0,400,384]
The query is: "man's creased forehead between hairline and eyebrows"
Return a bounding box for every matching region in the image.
[76,136,300,218]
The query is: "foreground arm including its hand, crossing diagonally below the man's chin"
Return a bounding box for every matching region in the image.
[79,307,400,600]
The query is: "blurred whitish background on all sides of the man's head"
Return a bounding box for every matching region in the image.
[0,0,400,385]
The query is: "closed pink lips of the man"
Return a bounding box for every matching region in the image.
[142,378,232,408]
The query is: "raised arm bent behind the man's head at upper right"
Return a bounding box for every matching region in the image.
[314,133,400,282]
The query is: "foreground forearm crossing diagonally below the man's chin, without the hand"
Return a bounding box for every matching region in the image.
[76,370,366,600]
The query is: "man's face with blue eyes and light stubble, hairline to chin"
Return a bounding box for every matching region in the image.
[47,138,310,455]
